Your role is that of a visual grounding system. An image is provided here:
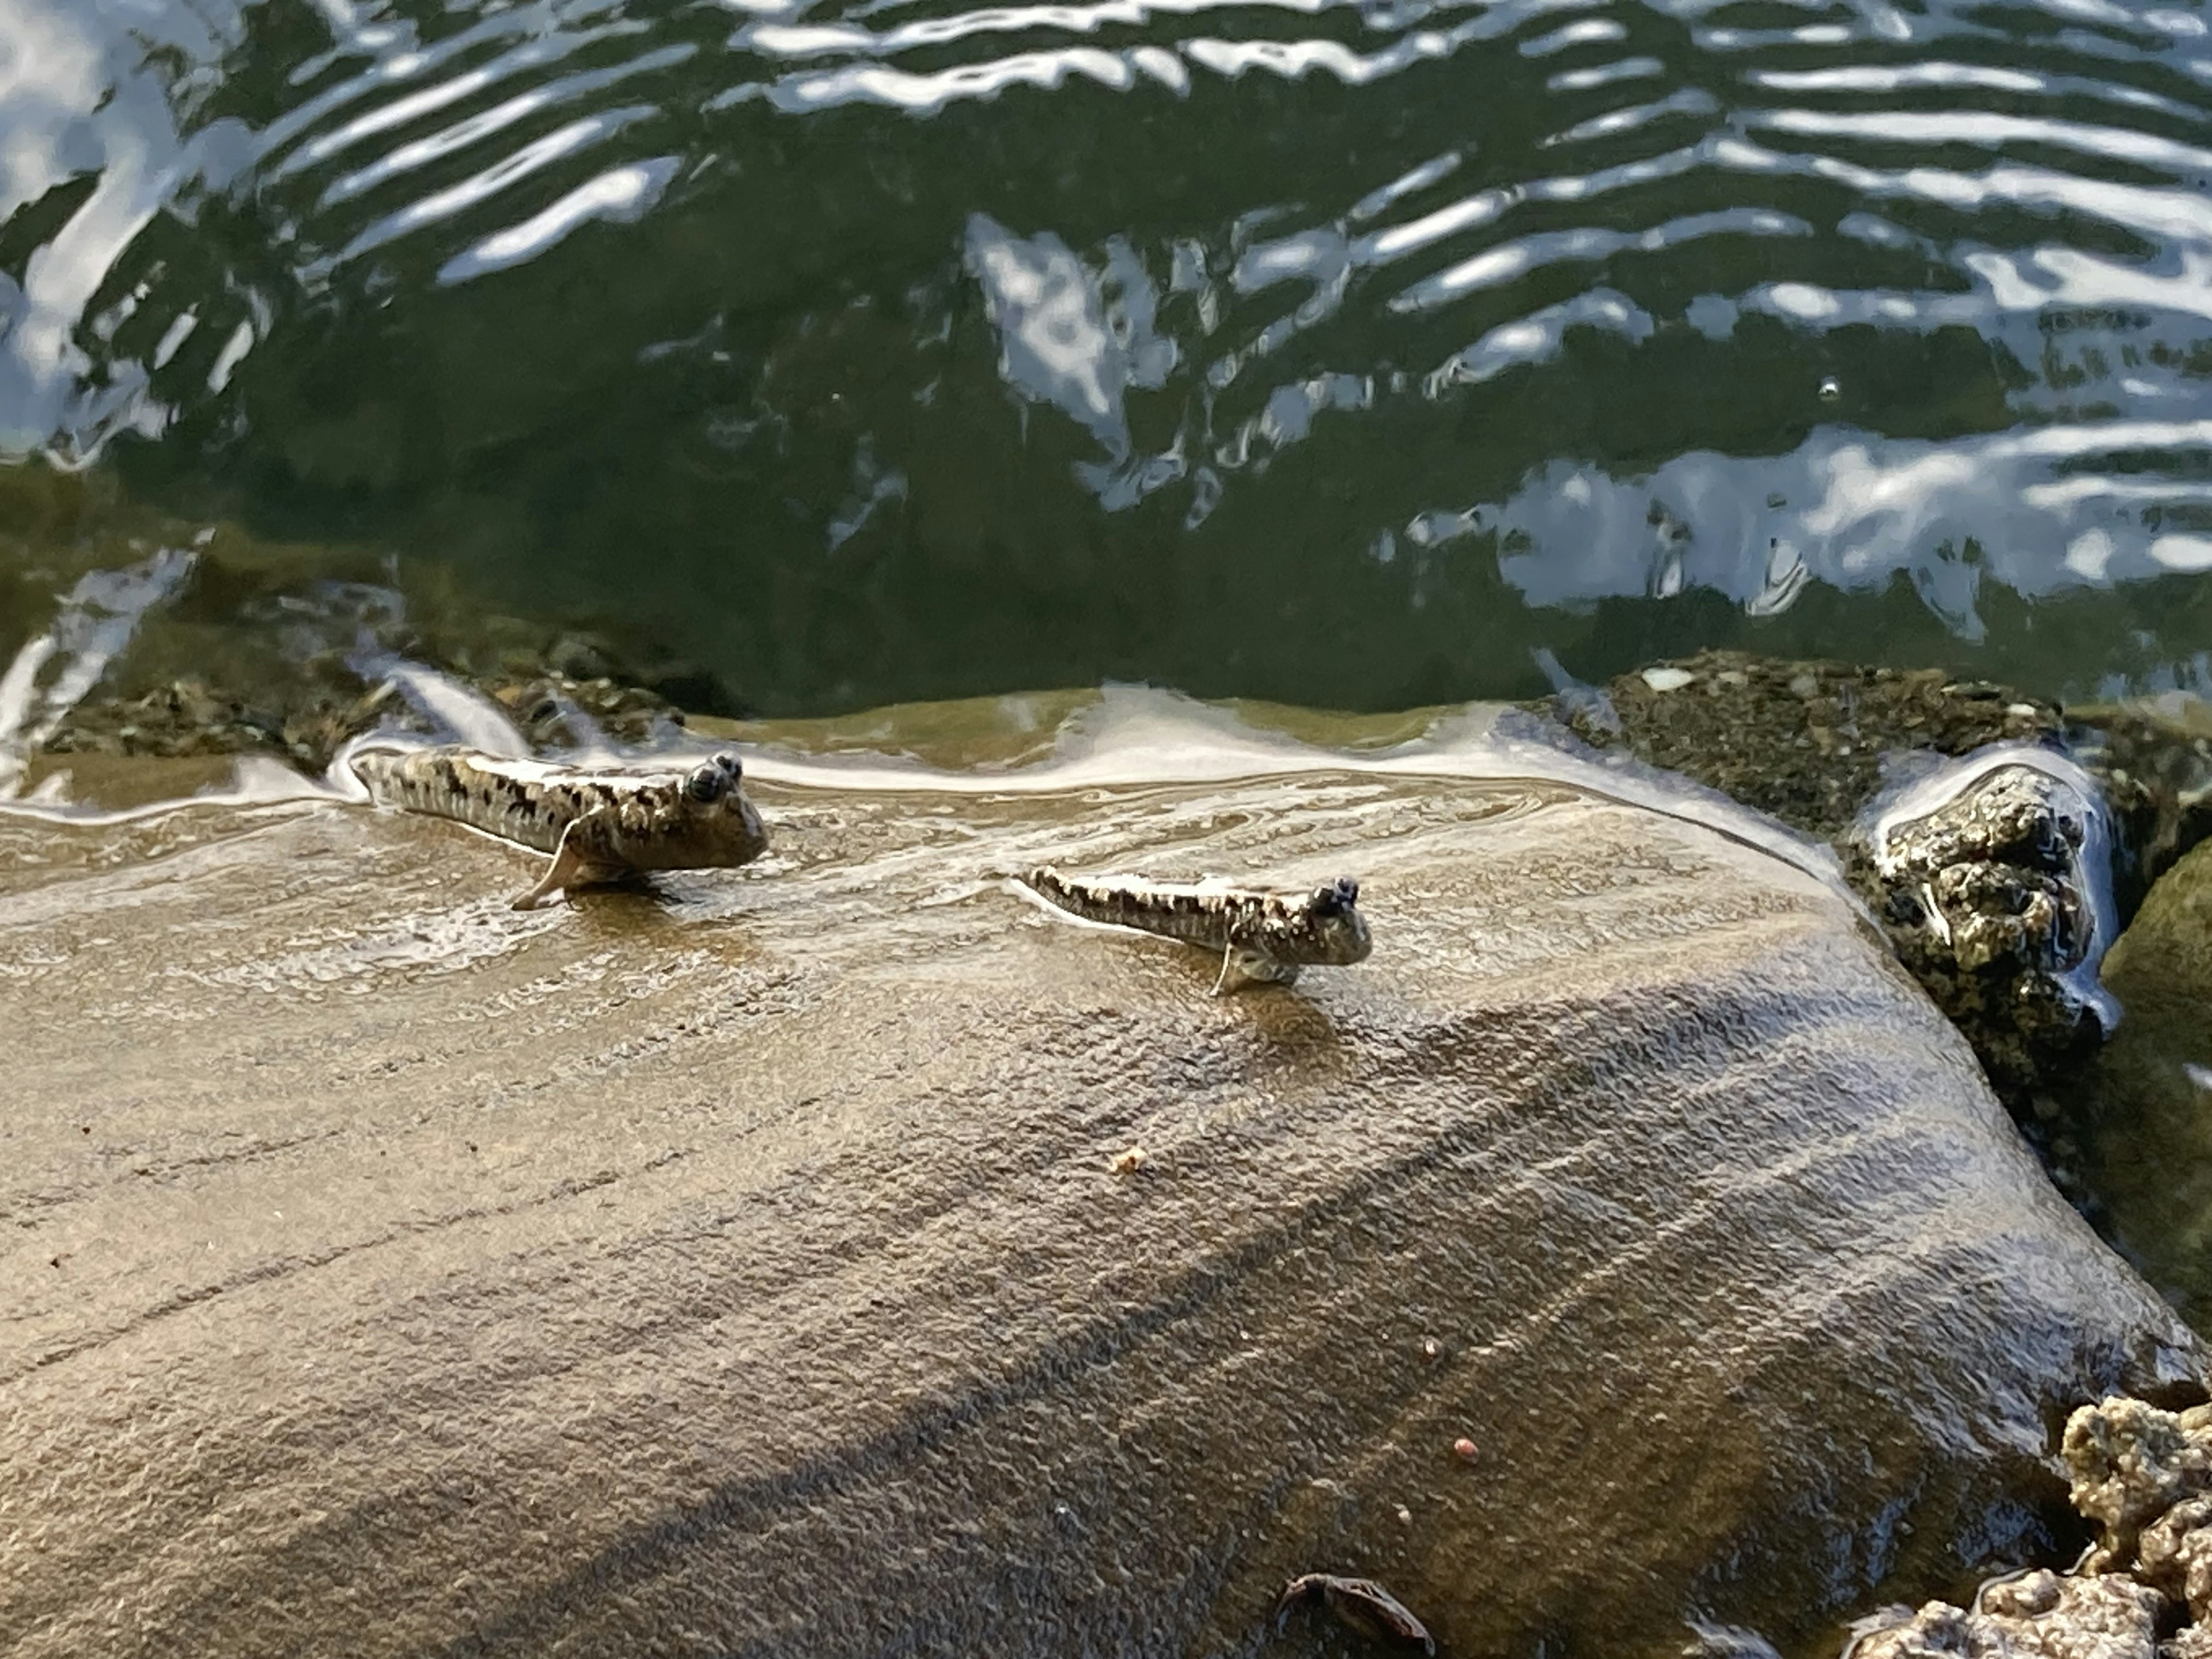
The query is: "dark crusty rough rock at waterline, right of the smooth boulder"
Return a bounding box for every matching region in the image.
[1546,650,2212,1119]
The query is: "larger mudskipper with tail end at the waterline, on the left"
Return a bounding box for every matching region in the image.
[347,748,767,909]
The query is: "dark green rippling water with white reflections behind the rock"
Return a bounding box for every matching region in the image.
[0,0,2212,712]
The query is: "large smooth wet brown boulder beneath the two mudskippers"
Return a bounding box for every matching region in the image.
[0,712,2199,1659]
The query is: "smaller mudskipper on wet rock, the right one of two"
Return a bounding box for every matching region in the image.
[1022,865,1374,995]
